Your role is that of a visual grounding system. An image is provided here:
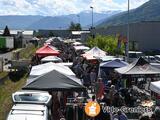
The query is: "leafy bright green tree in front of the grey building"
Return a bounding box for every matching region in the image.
[87,35,124,55]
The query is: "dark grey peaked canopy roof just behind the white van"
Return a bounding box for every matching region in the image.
[23,70,85,91]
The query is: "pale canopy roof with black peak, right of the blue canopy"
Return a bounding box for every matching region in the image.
[115,57,160,75]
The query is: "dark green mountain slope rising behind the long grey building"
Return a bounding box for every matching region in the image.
[97,0,160,27]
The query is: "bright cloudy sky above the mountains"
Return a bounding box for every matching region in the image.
[0,0,148,16]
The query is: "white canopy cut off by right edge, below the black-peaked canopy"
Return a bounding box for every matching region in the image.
[150,81,160,94]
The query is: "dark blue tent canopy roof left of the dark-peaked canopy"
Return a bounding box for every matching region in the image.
[100,59,128,68]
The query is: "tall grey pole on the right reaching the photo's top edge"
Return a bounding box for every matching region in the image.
[126,0,130,61]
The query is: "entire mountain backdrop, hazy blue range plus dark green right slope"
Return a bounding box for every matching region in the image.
[0,0,160,30]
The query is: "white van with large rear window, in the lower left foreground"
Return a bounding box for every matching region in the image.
[7,90,51,120]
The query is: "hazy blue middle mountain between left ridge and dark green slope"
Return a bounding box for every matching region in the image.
[28,12,119,29]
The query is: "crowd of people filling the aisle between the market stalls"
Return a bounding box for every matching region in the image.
[30,39,160,120]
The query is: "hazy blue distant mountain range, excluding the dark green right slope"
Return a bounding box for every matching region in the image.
[0,11,119,30]
